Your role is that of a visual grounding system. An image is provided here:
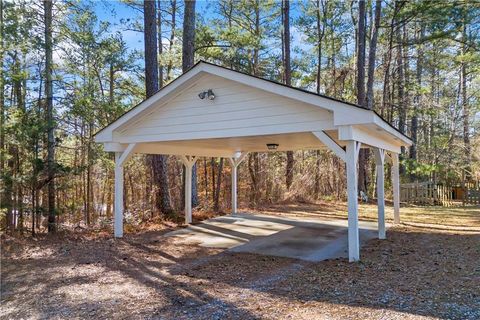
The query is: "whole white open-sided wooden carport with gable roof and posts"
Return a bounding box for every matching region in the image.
[95,62,412,261]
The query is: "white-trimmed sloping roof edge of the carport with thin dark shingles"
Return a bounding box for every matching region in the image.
[94,60,411,144]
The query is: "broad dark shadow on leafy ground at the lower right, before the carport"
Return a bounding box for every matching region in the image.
[170,228,480,319]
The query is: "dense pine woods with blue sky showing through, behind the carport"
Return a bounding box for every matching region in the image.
[0,0,480,233]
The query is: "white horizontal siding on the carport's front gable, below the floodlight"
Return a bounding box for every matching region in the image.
[114,75,333,143]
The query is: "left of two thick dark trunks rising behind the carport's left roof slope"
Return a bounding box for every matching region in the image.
[144,1,172,214]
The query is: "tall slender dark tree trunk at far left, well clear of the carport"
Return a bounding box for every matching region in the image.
[43,0,57,233]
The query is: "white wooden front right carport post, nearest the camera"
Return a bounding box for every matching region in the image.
[345,140,360,262]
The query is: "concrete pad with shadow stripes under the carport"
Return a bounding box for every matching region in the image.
[166,213,377,261]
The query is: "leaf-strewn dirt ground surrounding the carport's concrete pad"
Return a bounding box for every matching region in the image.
[0,204,480,319]
